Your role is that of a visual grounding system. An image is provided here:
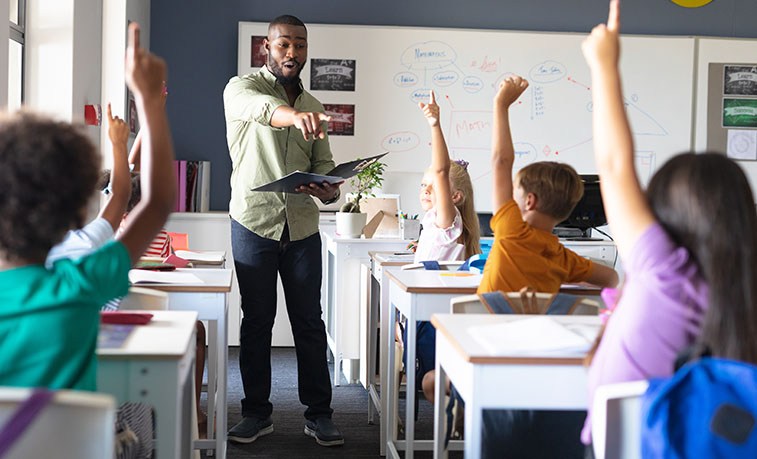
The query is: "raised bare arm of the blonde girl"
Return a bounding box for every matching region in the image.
[418,91,455,228]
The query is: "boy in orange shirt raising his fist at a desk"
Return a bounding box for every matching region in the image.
[446,76,618,457]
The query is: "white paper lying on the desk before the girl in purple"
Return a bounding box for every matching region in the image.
[468,316,598,356]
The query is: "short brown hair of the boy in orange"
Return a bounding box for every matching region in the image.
[517,161,584,223]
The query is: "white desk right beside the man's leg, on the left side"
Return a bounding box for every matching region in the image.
[130,268,233,459]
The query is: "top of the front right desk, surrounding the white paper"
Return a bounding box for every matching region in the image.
[431,314,602,365]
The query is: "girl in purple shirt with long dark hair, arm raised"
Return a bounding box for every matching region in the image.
[581,0,757,456]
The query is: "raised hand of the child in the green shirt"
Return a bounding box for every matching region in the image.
[125,22,166,104]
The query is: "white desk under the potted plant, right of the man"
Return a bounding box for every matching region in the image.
[322,231,411,386]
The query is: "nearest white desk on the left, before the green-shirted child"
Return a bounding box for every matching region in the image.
[97,311,197,459]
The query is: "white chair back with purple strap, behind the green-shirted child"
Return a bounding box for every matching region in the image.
[0,387,116,459]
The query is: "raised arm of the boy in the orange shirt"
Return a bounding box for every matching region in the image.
[491,76,528,213]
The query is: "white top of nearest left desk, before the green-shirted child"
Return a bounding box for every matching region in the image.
[97,311,197,360]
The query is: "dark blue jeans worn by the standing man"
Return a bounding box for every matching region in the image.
[231,220,333,420]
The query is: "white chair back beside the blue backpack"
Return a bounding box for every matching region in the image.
[591,381,649,459]
